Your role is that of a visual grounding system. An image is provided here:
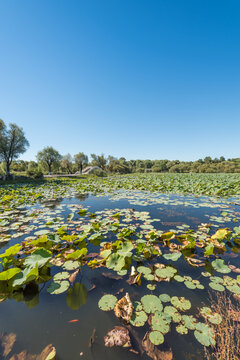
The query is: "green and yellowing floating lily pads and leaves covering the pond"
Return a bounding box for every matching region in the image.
[0,174,240,359]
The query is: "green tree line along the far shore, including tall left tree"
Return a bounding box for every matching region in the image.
[0,119,240,177]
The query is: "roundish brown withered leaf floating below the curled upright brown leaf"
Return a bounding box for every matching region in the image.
[104,326,131,348]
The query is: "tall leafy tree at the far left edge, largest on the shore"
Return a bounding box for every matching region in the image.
[0,119,29,176]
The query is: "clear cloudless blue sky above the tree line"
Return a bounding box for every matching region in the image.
[0,0,240,160]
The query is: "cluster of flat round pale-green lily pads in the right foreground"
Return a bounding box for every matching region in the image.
[98,294,218,346]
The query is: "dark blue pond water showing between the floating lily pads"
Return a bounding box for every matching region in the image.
[0,191,240,360]
